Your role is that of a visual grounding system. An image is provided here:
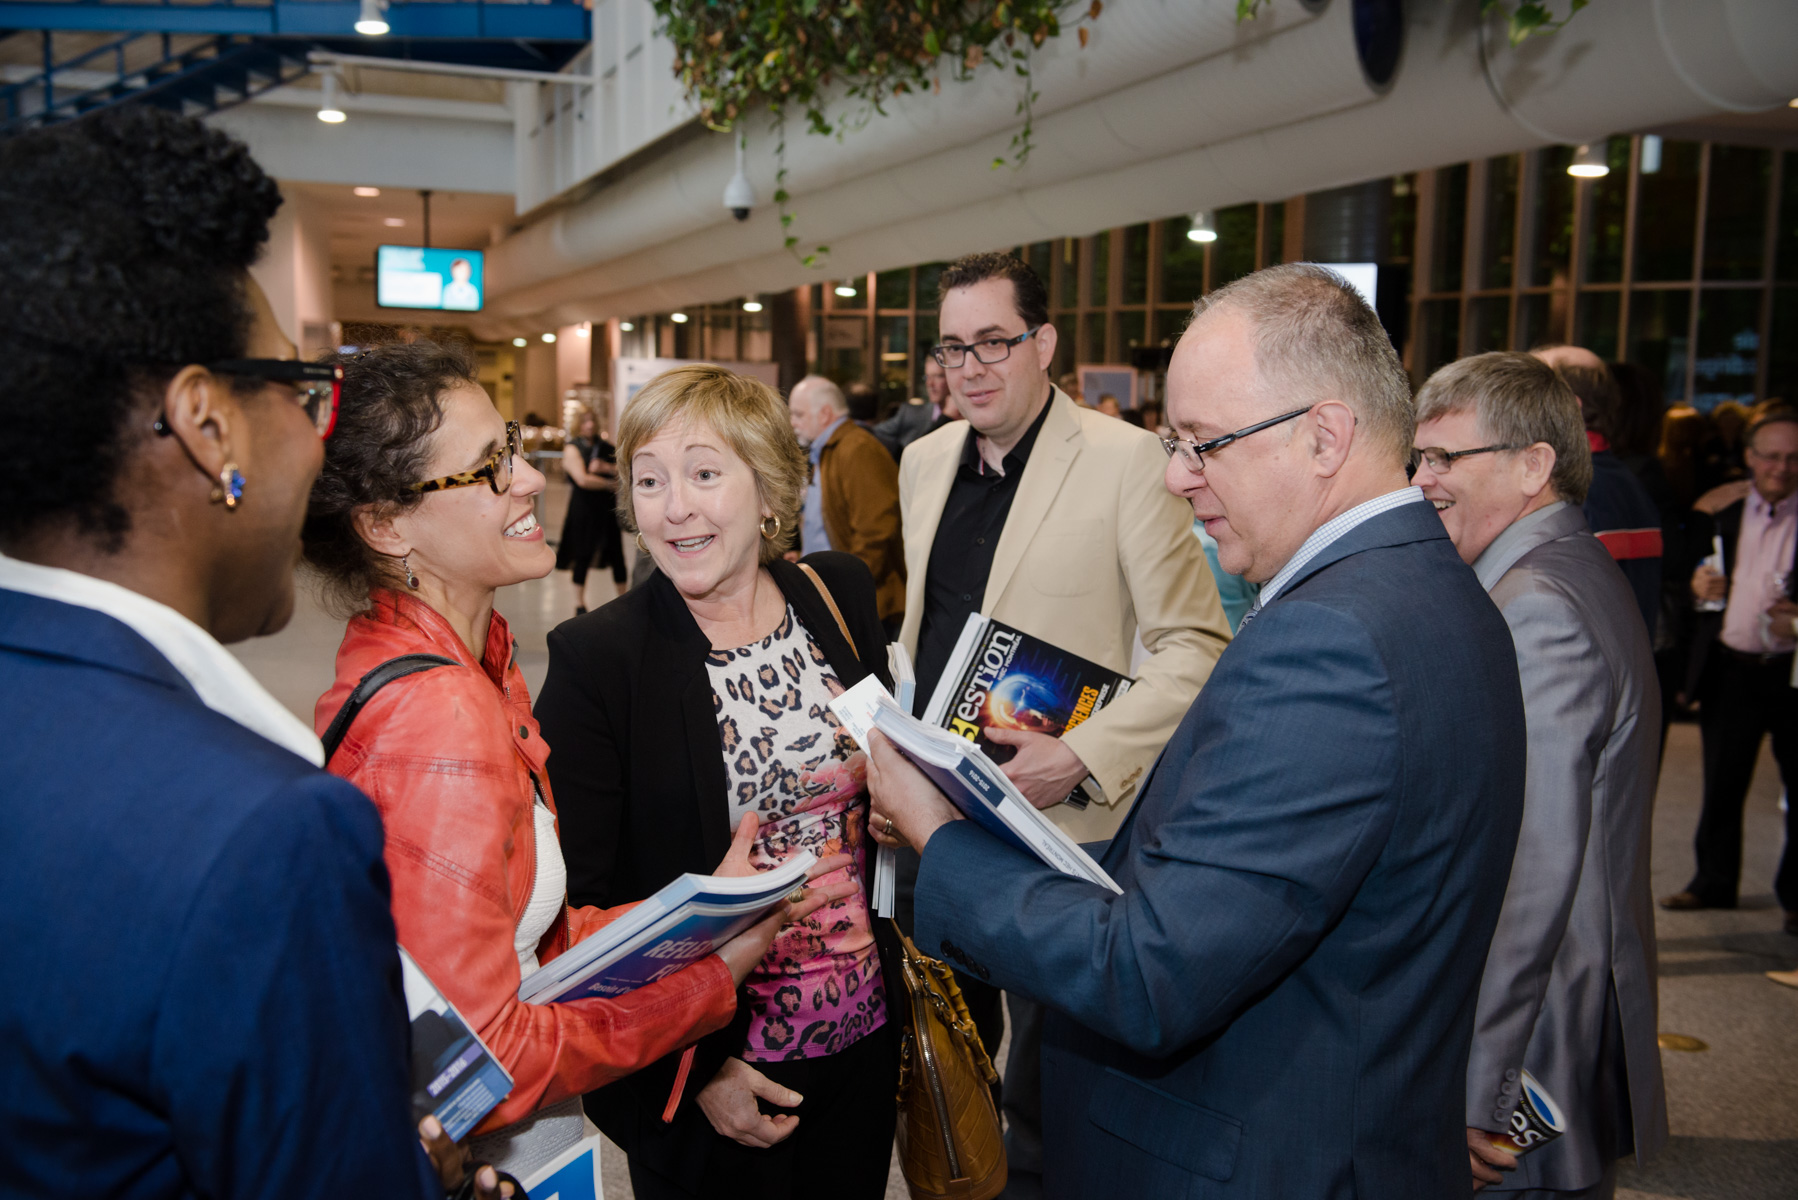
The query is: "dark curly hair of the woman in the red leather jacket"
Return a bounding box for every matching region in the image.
[300,338,476,615]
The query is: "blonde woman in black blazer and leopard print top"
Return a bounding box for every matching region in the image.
[536,367,906,1200]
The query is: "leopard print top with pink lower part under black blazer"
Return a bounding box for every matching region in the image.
[707,606,886,1061]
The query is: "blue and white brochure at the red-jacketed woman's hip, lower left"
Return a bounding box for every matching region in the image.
[399,946,512,1141]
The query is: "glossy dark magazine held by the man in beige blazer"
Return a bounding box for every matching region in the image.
[924,613,1135,763]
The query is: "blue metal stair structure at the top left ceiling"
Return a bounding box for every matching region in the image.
[0,0,592,137]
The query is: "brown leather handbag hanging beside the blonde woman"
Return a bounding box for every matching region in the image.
[895,927,1005,1200]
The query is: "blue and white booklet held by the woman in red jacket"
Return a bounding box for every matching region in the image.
[518,849,818,1004]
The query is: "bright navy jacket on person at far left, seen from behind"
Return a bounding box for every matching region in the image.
[0,590,442,1200]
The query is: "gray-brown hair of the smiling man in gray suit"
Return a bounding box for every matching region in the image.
[1417,351,1591,504]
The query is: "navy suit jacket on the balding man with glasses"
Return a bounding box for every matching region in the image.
[917,504,1525,1200]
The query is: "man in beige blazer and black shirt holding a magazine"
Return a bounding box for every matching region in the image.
[899,254,1230,1195]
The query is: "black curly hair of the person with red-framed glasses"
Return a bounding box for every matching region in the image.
[0,106,280,552]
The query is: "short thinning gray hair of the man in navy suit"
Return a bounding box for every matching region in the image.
[1192,263,1417,462]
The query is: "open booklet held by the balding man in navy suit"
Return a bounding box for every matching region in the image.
[831,675,1124,896]
